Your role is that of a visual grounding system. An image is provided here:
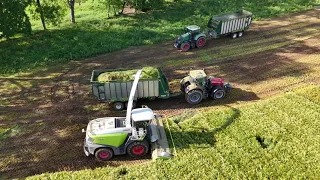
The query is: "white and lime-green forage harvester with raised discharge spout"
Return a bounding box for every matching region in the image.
[83,70,171,161]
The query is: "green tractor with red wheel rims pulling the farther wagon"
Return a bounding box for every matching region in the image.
[174,25,206,51]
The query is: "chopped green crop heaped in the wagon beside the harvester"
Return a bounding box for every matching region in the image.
[97,67,159,82]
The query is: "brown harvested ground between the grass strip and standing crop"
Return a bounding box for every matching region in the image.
[0,9,320,179]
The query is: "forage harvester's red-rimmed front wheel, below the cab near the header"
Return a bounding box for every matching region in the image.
[127,141,149,158]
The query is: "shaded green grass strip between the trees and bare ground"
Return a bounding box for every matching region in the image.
[0,0,319,75]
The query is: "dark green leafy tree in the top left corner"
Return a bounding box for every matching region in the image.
[0,0,31,39]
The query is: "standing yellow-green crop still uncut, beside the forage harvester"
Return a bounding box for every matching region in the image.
[28,86,320,179]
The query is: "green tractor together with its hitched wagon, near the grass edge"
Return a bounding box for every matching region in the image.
[174,10,252,51]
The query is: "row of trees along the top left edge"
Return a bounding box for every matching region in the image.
[0,0,165,39]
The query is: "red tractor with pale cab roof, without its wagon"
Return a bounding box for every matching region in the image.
[180,70,232,104]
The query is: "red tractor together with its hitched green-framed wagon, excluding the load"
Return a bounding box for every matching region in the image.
[90,68,232,110]
